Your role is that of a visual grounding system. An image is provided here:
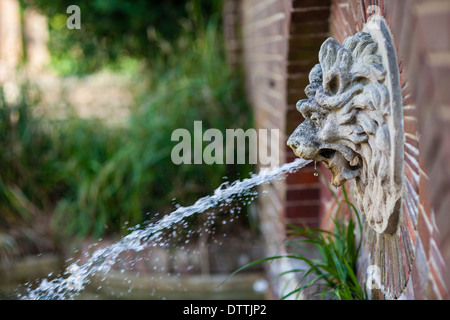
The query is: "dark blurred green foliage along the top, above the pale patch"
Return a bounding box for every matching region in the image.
[21,0,222,75]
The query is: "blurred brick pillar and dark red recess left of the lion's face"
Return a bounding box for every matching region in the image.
[224,0,330,249]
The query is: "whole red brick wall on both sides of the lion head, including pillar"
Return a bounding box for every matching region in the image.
[225,0,450,299]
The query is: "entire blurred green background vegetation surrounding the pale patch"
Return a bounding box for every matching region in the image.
[0,0,252,259]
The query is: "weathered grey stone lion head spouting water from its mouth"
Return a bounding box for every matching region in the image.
[288,19,403,233]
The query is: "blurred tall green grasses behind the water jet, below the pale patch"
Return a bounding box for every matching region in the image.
[0,16,252,243]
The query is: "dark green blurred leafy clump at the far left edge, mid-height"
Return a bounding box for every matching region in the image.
[0,87,56,220]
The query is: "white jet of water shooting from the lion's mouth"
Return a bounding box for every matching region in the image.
[19,158,311,300]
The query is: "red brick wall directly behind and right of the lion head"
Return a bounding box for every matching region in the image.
[330,0,450,299]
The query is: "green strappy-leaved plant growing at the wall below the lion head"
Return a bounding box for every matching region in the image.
[233,186,367,300]
